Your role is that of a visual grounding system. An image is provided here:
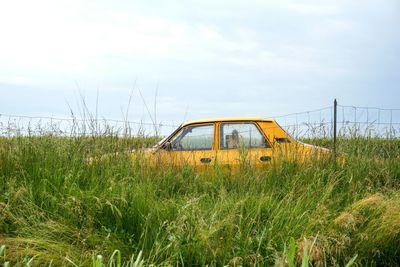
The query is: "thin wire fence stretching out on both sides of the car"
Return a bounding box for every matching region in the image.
[0,100,400,139]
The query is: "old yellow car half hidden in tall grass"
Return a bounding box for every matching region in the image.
[146,117,331,170]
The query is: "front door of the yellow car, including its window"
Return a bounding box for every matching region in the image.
[155,123,215,170]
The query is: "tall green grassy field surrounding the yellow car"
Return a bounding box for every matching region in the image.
[0,136,400,266]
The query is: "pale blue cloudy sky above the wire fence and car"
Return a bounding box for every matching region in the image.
[0,0,400,128]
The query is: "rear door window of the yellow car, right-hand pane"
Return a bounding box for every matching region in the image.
[220,123,270,149]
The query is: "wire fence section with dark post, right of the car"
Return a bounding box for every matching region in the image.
[273,102,400,138]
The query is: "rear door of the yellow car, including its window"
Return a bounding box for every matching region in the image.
[216,122,272,170]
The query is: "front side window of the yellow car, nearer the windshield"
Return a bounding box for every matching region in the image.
[171,125,214,151]
